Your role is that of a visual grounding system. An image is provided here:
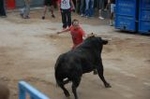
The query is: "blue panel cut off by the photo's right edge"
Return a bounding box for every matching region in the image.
[138,0,150,34]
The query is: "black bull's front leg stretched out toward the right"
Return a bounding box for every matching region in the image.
[97,64,111,88]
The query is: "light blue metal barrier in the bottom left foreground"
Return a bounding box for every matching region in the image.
[18,81,50,99]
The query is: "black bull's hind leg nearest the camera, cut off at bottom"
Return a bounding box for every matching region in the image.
[72,78,81,99]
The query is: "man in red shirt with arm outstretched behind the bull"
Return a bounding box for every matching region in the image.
[57,19,85,49]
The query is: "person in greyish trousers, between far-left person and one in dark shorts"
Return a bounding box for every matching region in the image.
[20,0,31,19]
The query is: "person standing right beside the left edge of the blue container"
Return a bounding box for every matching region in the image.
[108,0,116,26]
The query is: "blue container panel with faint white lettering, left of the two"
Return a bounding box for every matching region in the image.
[115,0,138,32]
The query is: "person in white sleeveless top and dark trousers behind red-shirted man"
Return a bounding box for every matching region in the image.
[58,0,75,29]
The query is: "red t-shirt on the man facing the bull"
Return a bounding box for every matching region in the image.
[70,26,85,49]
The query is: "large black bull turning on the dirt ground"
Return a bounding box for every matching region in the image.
[55,36,111,99]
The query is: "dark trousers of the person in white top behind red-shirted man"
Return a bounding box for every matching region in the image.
[61,9,71,28]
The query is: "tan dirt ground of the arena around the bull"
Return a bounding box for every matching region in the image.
[0,10,150,99]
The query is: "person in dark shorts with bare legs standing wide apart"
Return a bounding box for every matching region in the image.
[42,0,55,20]
